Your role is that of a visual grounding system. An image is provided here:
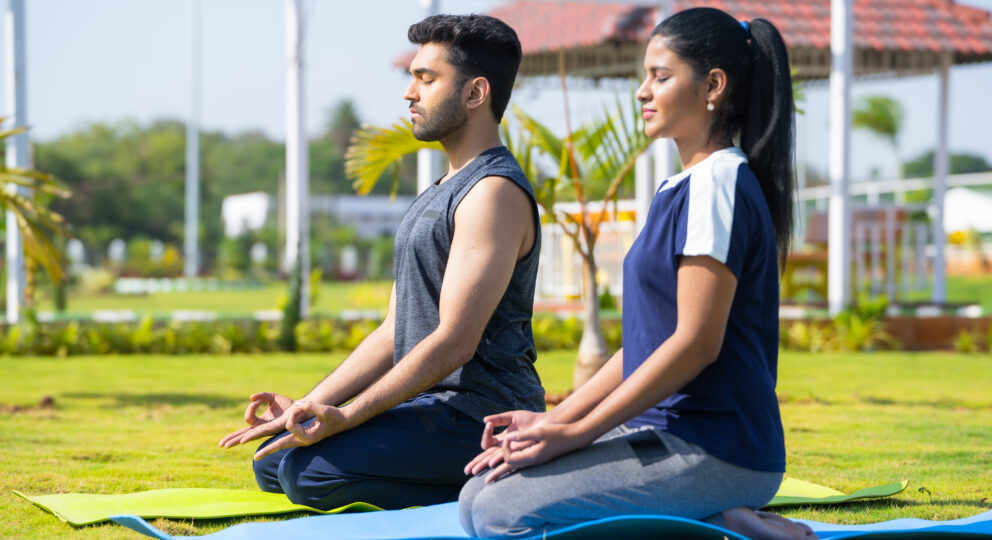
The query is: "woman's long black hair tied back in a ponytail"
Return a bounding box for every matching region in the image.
[651,8,795,268]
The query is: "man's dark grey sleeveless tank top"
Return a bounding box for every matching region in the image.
[393,146,544,421]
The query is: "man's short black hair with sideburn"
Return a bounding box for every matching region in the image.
[407,15,523,122]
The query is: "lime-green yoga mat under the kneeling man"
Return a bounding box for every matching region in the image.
[14,478,908,527]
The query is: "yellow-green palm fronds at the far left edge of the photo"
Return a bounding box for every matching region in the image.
[0,118,69,307]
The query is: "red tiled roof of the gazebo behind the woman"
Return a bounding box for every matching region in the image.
[395,0,992,67]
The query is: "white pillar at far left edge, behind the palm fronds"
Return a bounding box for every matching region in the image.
[4,0,30,323]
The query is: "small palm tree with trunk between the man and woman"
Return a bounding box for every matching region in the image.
[345,93,651,388]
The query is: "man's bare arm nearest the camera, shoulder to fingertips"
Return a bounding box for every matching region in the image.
[255,177,536,459]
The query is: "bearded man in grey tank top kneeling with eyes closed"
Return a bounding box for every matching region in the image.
[220,15,544,509]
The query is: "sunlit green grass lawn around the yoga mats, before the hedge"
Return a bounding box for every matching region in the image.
[0,352,992,538]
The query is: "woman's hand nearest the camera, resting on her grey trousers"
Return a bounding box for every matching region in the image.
[486,422,592,484]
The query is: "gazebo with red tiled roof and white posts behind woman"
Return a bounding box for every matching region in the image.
[396,0,992,312]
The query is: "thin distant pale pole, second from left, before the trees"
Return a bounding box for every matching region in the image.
[183,0,201,278]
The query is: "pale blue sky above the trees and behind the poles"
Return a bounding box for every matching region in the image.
[0,0,992,180]
